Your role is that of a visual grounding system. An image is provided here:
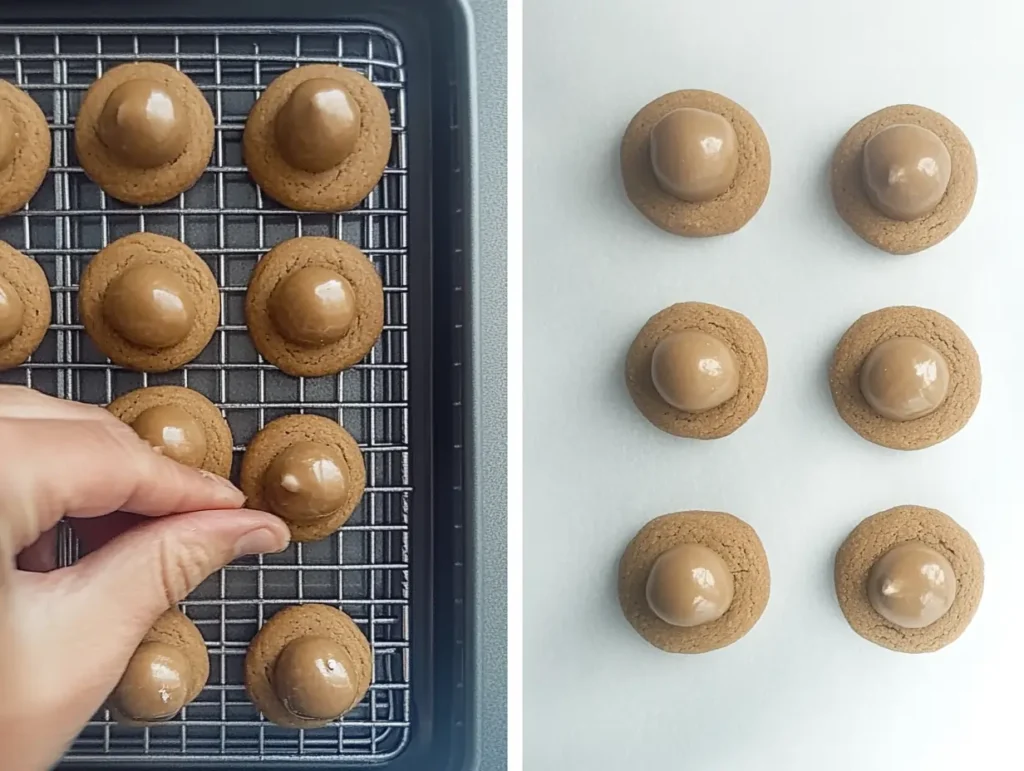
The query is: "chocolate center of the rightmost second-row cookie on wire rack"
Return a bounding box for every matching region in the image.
[267,265,355,346]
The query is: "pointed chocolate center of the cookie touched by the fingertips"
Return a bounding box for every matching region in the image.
[263,441,348,521]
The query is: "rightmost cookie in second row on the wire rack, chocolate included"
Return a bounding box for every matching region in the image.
[246,235,384,377]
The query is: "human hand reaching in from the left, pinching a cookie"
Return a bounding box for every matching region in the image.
[0,386,289,771]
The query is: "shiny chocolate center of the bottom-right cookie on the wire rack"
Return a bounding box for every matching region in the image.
[272,636,356,720]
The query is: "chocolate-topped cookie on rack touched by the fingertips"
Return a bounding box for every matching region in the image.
[239,415,367,541]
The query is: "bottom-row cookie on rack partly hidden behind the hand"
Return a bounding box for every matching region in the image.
[108,608,210,726]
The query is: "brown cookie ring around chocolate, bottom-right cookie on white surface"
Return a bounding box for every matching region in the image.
[836,506,985,653]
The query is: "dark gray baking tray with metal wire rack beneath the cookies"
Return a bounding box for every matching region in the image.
[0,0,476,771]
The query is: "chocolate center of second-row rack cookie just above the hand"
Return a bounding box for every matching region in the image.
[103,263,196,349]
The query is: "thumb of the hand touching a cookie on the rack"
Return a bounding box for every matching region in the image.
[61,509,289,638]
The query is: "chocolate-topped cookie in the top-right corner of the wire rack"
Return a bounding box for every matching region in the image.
[242,65,391,212]
